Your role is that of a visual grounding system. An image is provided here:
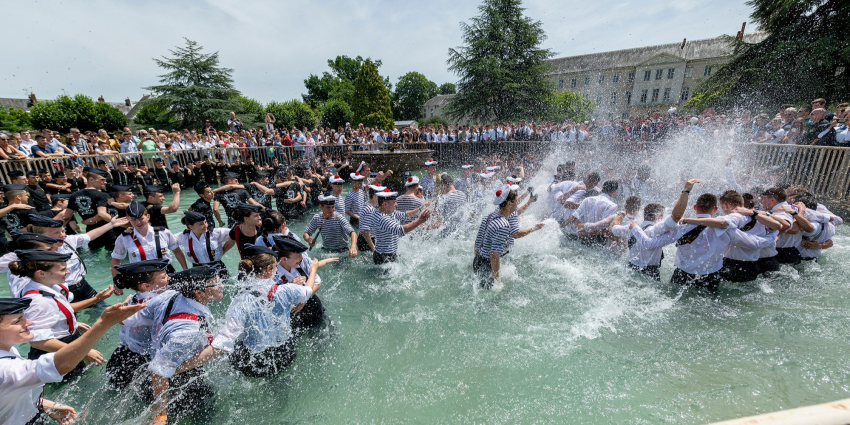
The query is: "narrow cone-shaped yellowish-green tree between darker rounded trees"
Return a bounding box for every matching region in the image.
[351,59,393,129]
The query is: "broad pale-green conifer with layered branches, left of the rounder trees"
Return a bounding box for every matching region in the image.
[145,38,239,128]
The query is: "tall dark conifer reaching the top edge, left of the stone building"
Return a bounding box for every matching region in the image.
[447,0,553,121]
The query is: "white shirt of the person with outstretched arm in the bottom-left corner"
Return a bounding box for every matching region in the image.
[0,347,62,425]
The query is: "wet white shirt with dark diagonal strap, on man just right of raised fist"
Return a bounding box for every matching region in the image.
[664,214,729,276]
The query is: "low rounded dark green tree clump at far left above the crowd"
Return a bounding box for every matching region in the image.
[30,94,127,133]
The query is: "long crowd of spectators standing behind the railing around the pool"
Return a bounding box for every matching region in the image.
[0,99,850,163]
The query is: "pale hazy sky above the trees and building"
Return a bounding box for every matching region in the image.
[0,0,755,103]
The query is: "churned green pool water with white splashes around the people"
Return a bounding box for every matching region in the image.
[0,183,850,424]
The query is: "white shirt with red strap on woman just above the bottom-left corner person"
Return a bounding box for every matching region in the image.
[21,281,77,342]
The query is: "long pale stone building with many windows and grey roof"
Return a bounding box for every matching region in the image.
[549,33,766,118]
